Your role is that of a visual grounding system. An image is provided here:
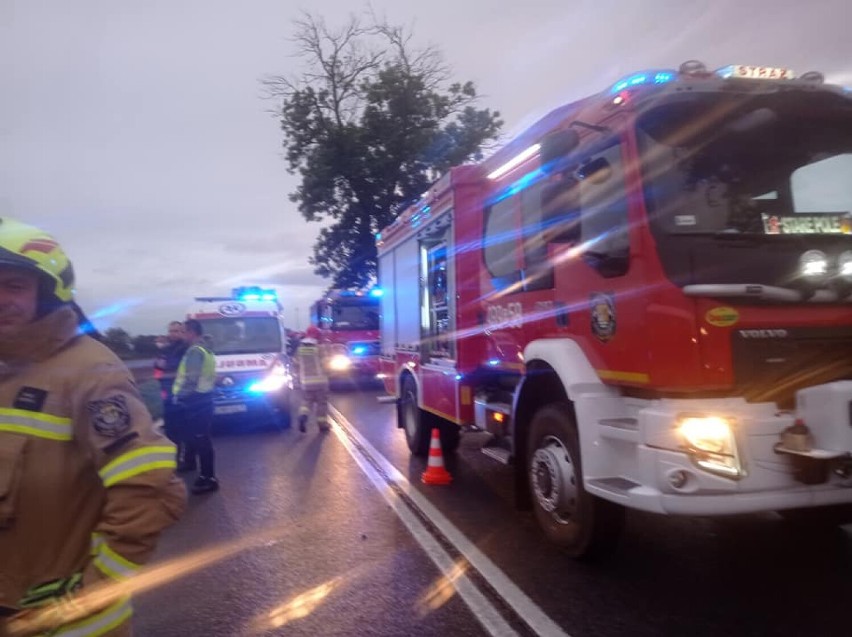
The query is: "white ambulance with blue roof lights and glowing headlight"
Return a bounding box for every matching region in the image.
[186,287,293,429]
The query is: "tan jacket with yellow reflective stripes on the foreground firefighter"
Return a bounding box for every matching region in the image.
[0,306,186,637]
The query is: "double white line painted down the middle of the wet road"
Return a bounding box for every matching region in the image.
[329,405,569,637]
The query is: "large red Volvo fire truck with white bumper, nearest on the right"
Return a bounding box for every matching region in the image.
[377,61,852,557]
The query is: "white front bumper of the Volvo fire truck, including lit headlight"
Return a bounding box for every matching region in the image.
[583,381,852,515]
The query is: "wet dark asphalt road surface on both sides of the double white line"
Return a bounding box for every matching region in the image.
[134,391,852,637]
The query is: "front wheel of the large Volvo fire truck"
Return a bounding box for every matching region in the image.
[527,403,624,559]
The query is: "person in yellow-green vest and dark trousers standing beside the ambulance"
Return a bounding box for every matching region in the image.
[172,319,219,493]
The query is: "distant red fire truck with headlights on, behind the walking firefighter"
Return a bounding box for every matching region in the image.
[311,288,381,382]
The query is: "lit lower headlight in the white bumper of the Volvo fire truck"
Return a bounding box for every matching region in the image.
[677,414,743,478]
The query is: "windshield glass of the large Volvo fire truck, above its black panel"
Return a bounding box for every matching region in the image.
[637,92,852,235]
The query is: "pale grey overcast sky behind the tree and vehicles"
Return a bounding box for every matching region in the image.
[0,0,852,334]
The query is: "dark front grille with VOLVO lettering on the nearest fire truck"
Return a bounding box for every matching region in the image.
[731,327,852,409]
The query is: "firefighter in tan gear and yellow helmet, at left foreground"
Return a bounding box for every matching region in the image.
[0,218,185,637]
